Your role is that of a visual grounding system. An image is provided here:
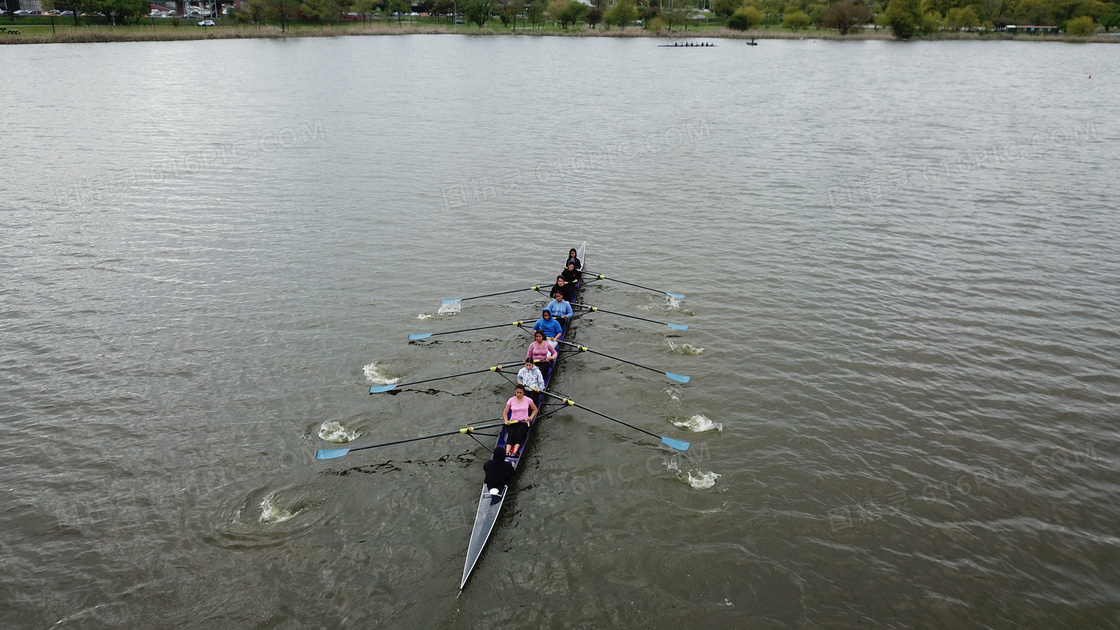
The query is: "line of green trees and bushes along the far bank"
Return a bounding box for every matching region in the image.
[30,0,1120,39]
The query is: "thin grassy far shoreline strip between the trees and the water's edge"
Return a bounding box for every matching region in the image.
[0,24,1120,45]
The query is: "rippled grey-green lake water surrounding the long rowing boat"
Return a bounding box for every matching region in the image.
[0,36,1120,629]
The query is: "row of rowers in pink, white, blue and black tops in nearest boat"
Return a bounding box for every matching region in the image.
[494,249,582,460]
